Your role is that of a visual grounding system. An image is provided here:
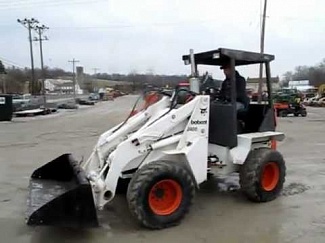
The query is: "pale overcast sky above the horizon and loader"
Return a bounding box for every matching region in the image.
[0,0,325,78]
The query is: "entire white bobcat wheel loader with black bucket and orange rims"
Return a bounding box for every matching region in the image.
[26,48,286,229]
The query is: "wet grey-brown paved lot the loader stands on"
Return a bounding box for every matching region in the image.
[0,97,325,243]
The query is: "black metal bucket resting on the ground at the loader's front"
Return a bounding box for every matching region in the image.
[26,154,98,228]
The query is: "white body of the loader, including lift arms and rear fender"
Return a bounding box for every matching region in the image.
[81,95,284,209]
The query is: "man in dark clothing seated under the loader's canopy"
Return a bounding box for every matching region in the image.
[220,63,249,111]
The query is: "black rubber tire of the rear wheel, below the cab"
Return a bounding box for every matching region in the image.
[239,148,286,202]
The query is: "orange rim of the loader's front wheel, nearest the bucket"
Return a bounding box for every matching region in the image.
[149,180,183,215]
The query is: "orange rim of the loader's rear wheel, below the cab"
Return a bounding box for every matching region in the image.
[262,162,280,191]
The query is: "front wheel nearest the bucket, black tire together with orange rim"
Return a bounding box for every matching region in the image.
[127,161,195,229]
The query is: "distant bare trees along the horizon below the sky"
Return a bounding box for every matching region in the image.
[0,58,325,93]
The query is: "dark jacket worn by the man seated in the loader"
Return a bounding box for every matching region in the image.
[220,71,247,105]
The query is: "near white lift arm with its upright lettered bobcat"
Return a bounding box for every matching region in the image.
[88,96,209,209]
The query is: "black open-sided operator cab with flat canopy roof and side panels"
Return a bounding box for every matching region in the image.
[182,48,276,148]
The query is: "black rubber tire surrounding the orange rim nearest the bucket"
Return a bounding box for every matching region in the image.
[127,161,195,229]
